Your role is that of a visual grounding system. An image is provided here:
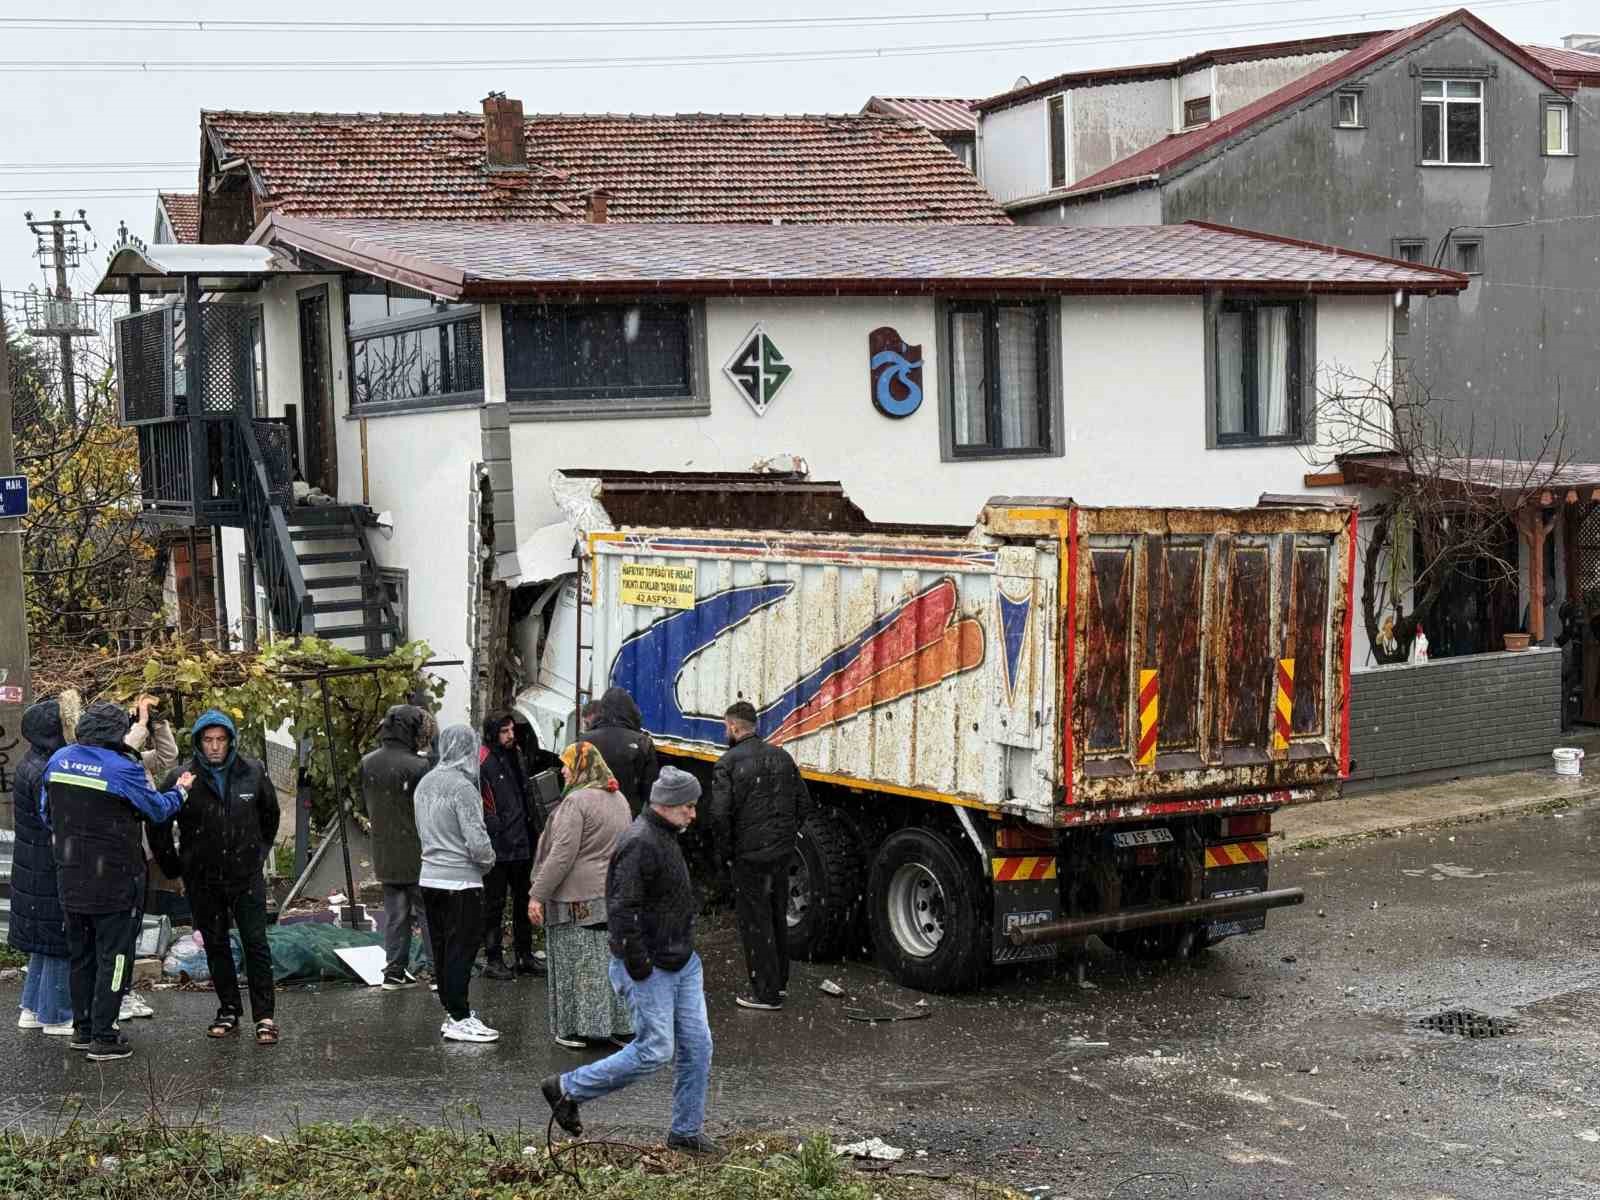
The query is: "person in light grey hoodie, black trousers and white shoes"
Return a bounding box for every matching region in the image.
[414,725,499,1042]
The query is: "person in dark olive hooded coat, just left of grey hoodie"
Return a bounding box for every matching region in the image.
[362,704,430,992]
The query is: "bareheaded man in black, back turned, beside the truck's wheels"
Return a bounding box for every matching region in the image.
[710,701,811,1011]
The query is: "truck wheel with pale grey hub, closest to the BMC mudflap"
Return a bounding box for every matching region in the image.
[867,829,989,992]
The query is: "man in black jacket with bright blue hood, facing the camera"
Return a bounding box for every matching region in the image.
[150,709,278,1046]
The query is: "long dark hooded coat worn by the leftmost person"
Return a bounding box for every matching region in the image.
[6,701,67,958]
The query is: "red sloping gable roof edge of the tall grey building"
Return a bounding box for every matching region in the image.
[1053,8,1557,198]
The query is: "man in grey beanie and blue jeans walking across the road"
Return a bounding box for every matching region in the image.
[539,766,720,1154]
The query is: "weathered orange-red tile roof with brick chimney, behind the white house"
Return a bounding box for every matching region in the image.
[202,112,1008,224]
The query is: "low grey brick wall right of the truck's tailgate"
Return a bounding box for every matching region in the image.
[1350,650,1562,790]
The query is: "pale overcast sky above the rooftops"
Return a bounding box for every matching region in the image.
[0,0,1600,305]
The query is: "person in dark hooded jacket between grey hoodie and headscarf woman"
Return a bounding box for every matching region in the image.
[478,714,539,979]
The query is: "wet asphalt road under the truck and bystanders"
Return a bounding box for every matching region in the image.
[0,805,1600,1200]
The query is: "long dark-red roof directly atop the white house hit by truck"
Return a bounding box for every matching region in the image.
[256,216,1467,299]
